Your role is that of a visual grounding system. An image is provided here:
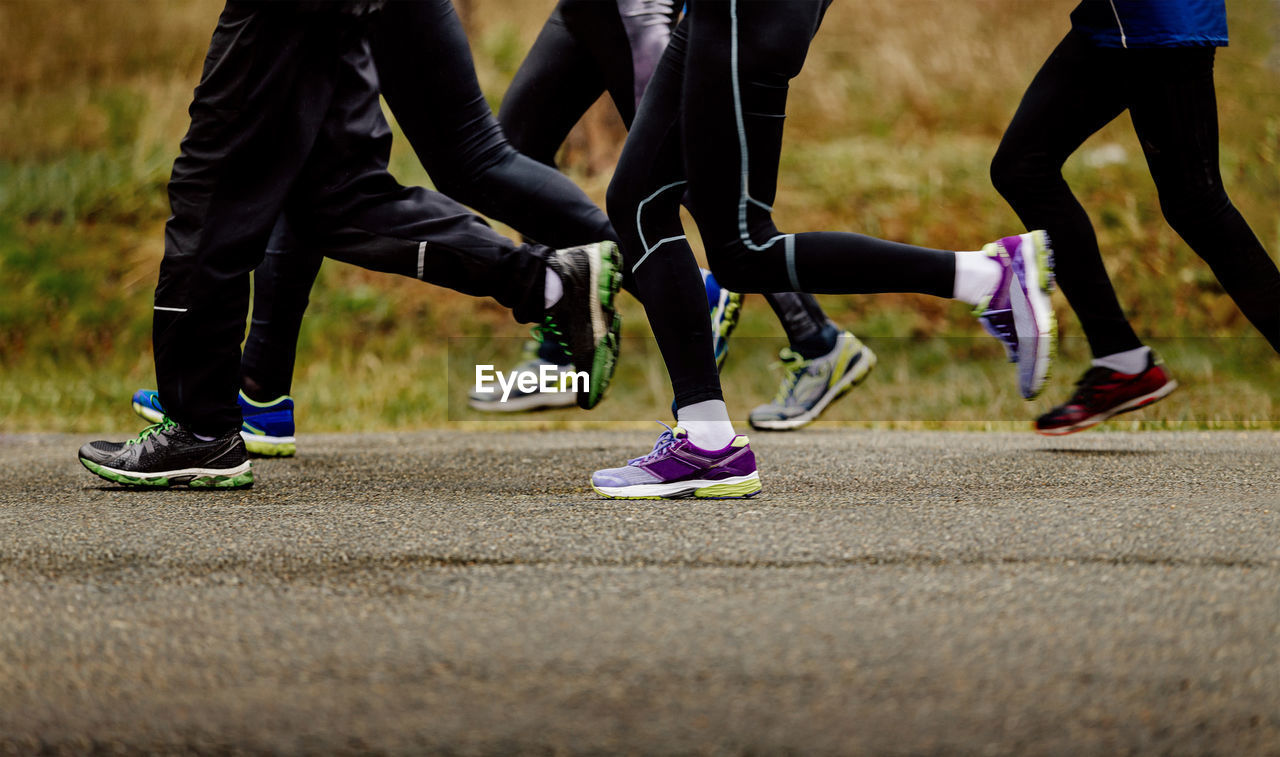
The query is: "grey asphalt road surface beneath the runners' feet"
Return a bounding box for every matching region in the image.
[0,432,1280,754]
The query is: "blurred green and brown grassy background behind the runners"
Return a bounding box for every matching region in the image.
[0,0,1280,432]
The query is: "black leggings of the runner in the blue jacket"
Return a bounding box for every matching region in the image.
[991,31,1280,357]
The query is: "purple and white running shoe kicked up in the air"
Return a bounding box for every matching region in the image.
[973,232,1057,400]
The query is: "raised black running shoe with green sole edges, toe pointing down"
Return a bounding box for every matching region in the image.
[543,242,622,410]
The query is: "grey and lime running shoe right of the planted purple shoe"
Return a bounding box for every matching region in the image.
[748,330,876,432]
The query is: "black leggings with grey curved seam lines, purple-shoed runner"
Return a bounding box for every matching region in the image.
[607,0,955,407]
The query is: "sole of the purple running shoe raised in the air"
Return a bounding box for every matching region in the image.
[1010,232,1057,400]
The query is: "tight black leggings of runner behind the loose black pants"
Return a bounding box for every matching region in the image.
[241,0,616,397]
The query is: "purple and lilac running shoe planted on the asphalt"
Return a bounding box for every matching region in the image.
[591,424,760,500]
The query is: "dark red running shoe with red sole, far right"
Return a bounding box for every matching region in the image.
[1036,352,1178,437]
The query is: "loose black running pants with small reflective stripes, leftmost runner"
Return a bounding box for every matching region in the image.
[154,1,547,434]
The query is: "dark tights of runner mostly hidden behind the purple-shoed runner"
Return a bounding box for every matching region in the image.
[498,0,829,353]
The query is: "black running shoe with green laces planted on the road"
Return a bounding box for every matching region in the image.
[79,416,253,489]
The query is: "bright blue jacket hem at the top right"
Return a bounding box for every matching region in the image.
[1071,0,1226,47]
